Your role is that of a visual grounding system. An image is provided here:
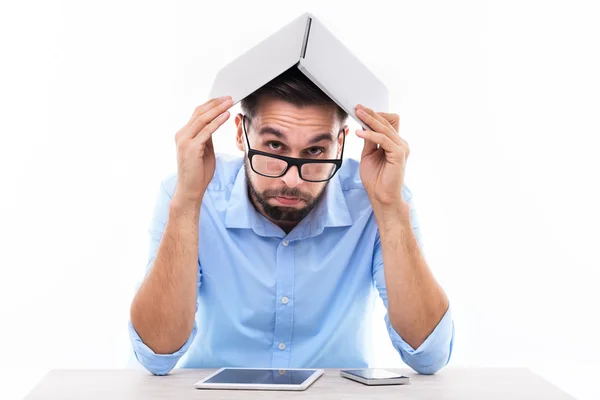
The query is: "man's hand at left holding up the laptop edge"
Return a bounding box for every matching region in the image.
[173,96,233,205]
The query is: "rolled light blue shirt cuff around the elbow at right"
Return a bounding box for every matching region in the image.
[386,307,454,375]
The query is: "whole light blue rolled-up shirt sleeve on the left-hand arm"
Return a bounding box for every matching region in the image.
[128,181,202,375]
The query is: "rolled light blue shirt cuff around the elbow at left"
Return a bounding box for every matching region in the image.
[129,321,198,375]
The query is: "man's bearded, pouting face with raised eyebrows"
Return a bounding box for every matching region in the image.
[235,99,347,227]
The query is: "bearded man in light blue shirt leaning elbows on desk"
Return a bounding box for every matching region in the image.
[129,68,454,375]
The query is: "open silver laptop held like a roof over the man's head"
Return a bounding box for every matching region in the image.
[210,13,389,129]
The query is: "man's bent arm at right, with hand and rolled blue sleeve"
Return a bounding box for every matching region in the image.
[356,105,454,374]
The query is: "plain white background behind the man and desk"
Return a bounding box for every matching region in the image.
[0,0,600,399]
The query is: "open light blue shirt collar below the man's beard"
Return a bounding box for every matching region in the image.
[225,164,352,239]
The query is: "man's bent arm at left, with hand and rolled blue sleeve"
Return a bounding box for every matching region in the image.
[129,97,232,375]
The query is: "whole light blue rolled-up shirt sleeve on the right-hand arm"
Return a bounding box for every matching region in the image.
[373,186,454,375]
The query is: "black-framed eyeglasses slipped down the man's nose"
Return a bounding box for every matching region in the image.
[242,115,346,182]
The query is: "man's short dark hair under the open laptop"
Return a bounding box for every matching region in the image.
[241,66,348,125]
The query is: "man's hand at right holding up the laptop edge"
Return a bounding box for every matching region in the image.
[356,104,410,208]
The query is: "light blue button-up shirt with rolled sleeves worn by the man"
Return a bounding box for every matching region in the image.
[129,156,454,375]
